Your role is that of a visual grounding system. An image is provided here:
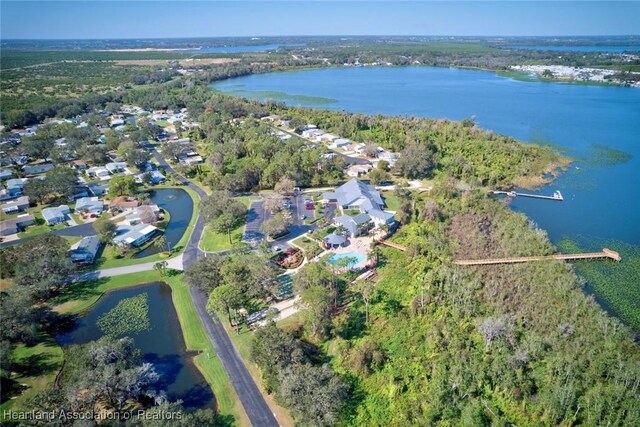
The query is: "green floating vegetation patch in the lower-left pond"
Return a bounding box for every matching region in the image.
[96,292,151,337]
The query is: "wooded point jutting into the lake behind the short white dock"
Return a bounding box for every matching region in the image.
[277,107,568,186]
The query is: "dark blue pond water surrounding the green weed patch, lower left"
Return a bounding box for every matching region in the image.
[56,283,214,408]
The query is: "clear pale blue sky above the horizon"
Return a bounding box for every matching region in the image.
[0,0,640,39]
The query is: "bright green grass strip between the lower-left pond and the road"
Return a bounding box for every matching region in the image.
[54,271,250,426]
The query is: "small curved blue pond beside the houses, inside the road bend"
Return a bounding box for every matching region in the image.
[134,188,193,258]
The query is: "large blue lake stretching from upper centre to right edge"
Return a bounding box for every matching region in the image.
[211,67,640,325]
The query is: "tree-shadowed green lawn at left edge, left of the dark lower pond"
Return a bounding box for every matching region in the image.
[0,334,64,419]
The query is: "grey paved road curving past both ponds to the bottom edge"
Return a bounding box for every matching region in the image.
[149,147,279,427]
